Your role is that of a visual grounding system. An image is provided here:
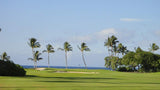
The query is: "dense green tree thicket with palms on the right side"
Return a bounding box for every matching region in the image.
[104,36,160,72]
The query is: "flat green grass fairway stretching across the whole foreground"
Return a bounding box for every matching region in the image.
[0,69,160,90]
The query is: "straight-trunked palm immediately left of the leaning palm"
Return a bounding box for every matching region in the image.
[58,42,72,69]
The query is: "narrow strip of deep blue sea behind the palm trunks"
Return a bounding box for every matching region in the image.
[22,65,111,70]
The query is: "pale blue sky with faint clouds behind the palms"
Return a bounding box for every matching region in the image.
[0,0,160,67]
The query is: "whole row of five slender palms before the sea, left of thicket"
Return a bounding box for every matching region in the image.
[28,38,90,69]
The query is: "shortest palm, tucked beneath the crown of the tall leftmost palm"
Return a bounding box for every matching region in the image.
[28,51,43,68]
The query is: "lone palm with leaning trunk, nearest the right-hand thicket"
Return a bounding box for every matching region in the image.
[78,42,90,69]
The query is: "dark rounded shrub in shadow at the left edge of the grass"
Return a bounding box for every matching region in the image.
[0,60,26,76]
